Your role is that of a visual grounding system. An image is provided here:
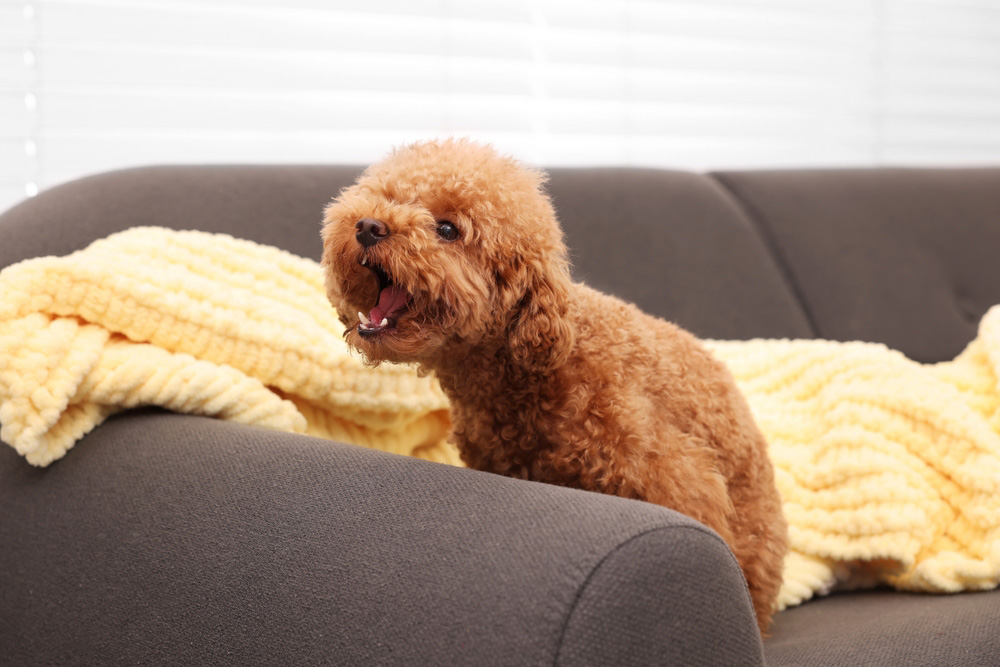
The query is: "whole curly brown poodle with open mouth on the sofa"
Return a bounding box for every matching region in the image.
[323,140,786,632]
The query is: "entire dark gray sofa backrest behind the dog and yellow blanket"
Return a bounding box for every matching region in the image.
[0,165,1000,361]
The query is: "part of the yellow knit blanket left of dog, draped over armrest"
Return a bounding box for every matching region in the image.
[0,227,459,466]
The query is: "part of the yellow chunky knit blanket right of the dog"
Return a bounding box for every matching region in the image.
[709,314,1000,608]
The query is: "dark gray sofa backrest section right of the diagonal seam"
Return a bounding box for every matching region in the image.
[717,169,1000,361]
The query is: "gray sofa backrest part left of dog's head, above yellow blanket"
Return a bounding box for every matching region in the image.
[0,165,361,267]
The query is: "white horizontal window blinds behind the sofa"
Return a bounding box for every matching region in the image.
[0,0,1000,214]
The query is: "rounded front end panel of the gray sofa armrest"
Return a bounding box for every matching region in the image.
[556,527,760,667]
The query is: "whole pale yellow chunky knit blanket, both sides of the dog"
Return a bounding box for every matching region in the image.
[0,228,1000,607]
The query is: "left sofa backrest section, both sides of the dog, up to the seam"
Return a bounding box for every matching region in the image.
[0,160,812,338]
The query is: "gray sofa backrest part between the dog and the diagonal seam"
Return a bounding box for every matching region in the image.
[549,169,814,338]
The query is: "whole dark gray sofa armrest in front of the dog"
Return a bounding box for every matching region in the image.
[0,409,762,665]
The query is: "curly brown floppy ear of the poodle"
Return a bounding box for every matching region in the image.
[507,261,576,371]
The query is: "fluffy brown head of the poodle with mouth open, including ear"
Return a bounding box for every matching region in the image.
[322,140,573,369]
